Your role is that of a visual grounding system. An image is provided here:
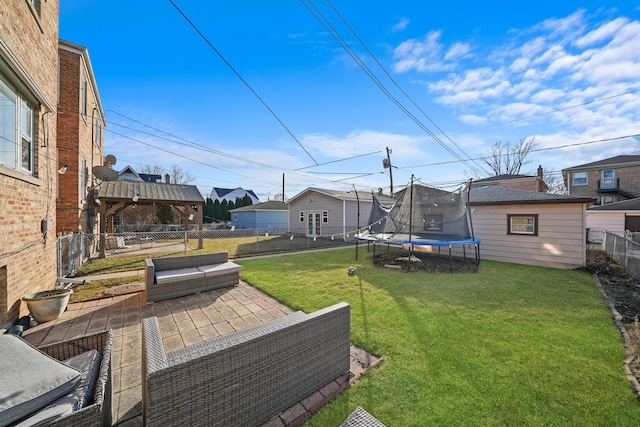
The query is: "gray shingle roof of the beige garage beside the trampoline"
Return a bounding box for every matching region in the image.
[469,187,593,205]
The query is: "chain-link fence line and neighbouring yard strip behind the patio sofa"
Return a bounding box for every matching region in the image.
[57,229,355,277]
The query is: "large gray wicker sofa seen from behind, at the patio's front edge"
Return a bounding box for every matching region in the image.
[142,303,350,427]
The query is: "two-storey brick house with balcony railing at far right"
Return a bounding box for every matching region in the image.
[562,155,640,205]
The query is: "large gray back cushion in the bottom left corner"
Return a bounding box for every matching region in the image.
[0,334,80,426]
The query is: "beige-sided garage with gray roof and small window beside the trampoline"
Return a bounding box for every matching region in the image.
[460,187,590,268]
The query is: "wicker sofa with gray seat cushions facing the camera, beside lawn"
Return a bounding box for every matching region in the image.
[145,252,242,302]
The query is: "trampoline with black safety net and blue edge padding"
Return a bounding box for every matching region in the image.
[355,177,480,271]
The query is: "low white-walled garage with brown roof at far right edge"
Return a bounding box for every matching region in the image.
[587,199,640,243]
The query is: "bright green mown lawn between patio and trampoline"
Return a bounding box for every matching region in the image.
[238,248,640,427]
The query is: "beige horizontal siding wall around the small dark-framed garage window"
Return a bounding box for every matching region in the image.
[453,203,586,268]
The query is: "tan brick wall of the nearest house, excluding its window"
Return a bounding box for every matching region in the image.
[0,0,58,324]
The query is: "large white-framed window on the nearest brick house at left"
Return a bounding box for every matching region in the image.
[0,75,35,175]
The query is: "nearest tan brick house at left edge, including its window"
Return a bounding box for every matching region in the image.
[0,0,62,328]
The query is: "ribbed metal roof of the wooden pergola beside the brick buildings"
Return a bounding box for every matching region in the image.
[98,180,204,203]
